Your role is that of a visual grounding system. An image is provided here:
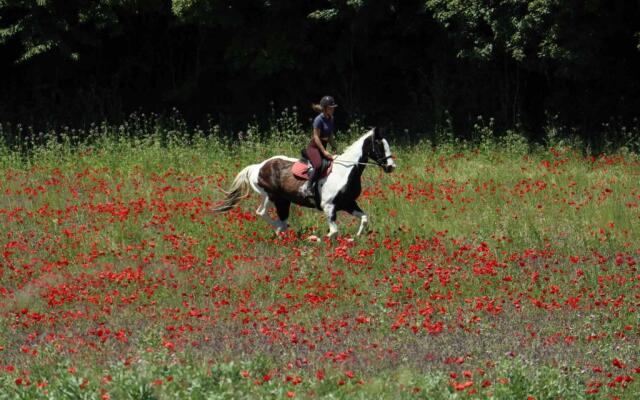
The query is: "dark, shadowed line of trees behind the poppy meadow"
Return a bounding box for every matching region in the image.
[0,0,640,144]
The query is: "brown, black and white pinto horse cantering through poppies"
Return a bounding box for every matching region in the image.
[213,128,396,238]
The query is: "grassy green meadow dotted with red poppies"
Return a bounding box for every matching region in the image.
[0,120,640,399]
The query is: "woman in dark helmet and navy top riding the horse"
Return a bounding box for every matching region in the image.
[307,96,338,193]
